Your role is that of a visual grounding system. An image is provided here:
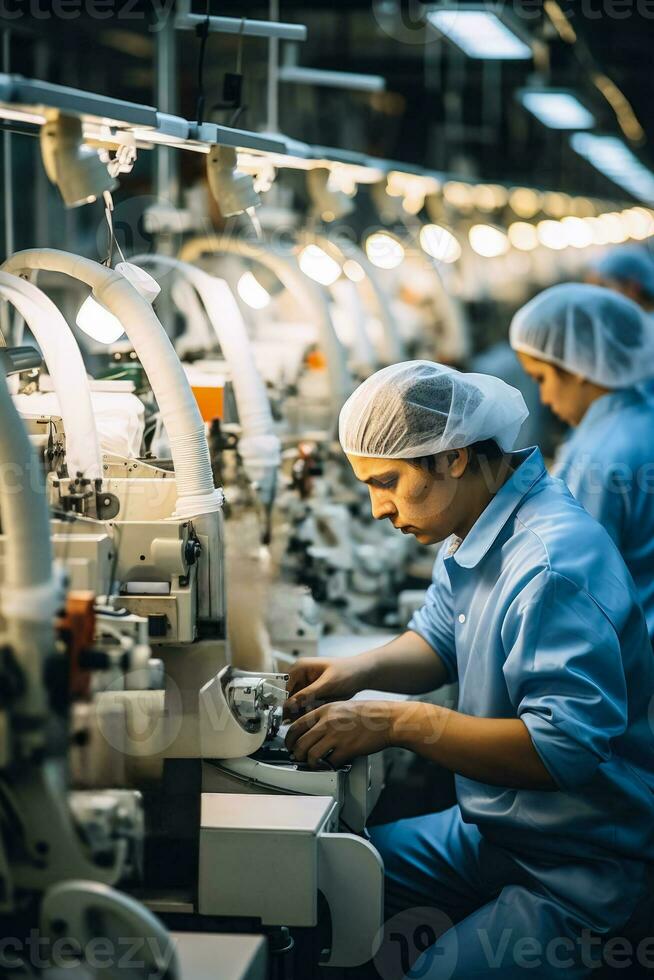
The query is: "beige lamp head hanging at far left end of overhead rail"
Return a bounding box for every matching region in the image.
[40,113,118,208]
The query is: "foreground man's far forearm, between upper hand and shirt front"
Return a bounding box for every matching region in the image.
[353,630,447,694]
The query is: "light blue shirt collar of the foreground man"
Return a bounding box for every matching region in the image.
[446,446,546,568]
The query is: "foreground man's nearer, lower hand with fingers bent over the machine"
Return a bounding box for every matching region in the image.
[286,701,397,769]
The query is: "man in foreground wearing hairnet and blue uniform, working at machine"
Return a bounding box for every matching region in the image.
[287,361,654,980]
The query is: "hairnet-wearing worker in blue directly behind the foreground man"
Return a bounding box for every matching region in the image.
[510,283,654,641]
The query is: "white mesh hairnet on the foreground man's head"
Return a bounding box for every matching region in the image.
[339,361,529,459]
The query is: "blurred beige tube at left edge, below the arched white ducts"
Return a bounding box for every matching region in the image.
[0,371,60,740]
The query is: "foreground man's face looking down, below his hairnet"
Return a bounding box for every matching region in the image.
[348,449,469,544]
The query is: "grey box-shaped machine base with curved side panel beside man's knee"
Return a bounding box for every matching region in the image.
[198,793,384,967]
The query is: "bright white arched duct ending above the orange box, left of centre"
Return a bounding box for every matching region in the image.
[130,255,281,482]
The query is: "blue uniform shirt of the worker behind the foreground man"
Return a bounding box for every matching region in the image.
[553,383,654,643]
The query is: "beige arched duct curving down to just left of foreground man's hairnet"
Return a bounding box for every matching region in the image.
[179,235,353,419]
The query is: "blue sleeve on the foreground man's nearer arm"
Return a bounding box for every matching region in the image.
[502,570,627,789]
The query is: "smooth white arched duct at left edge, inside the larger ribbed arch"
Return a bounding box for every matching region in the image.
[0,272,102,480]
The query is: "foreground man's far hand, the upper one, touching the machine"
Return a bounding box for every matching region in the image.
[284,657,365,718]
